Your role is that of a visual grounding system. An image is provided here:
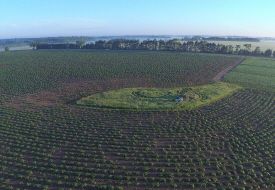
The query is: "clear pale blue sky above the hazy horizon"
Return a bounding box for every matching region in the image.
[0,0,275,39]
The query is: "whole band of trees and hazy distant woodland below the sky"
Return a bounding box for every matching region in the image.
[0,36,275,57]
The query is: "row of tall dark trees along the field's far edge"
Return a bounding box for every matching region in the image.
[30,39,275,57]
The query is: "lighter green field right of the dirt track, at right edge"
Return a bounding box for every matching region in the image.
[224,58,275,89]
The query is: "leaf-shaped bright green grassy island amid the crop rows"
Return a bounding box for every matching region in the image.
[77,82,239,110]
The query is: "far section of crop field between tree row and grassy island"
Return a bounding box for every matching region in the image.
[0,51,241,95]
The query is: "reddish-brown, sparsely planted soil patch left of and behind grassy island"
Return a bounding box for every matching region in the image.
[6,78,154,109]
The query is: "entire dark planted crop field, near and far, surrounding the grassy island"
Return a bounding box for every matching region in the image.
[0,51,275,190]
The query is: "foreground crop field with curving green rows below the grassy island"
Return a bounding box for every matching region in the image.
[0,89,275,189]
